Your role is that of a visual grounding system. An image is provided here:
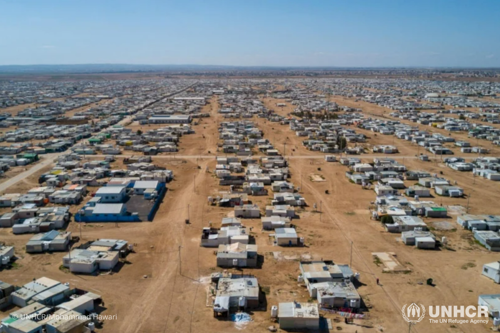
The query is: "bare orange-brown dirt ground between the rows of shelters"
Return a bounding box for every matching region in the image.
[0,86,500,332]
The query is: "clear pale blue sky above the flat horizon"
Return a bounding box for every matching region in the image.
[0,0,500,67]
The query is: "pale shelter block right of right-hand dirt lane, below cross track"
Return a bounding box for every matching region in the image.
[340,157,464,249]
